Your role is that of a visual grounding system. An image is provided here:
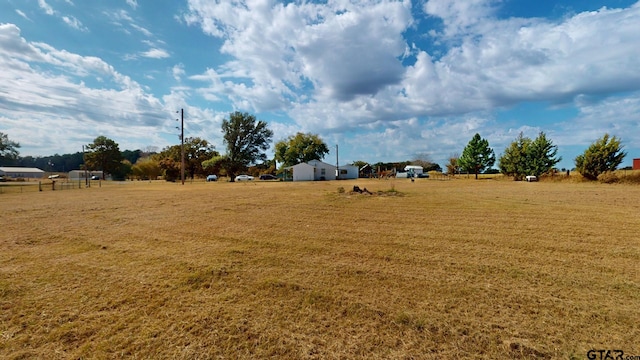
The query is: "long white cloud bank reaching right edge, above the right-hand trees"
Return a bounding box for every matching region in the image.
[404,2,640,114]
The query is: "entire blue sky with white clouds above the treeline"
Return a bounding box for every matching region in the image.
[0,0,640,168]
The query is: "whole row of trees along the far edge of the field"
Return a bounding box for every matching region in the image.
[0,115,626,181]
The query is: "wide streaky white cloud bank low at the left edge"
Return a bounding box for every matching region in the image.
[0,24,172,156]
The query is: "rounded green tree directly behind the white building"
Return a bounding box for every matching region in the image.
[275,133,329,167]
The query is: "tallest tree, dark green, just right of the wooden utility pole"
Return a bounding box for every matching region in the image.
[218,111,273,181]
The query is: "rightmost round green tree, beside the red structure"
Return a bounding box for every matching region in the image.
[575,134,627,180]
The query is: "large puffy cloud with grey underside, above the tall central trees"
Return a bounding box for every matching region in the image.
[185,0,411,111]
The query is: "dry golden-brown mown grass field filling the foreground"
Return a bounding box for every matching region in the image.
[0,179,640,359]
